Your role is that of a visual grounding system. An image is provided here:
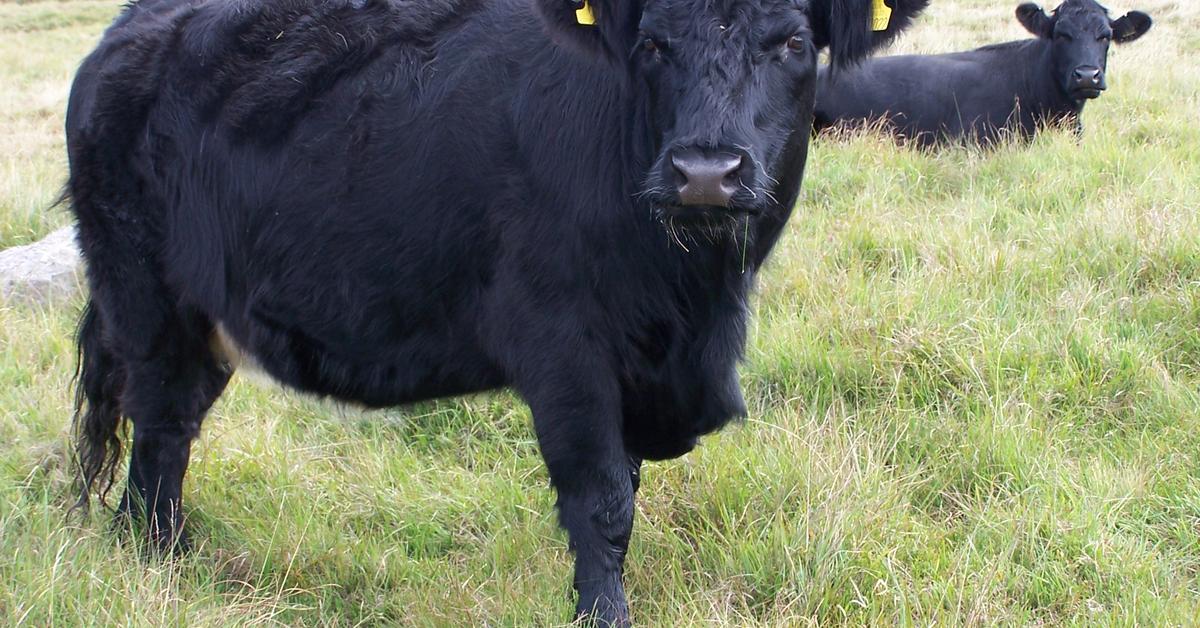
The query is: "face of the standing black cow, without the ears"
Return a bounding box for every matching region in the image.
[631,0,817,219]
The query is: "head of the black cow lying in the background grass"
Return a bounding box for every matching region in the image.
[1016,0,1151,101]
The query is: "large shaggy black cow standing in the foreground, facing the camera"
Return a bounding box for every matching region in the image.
[66,0,928,623]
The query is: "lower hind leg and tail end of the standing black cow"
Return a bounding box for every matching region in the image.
[76,285,229,550]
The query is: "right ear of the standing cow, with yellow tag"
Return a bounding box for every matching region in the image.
[809,0,929,67]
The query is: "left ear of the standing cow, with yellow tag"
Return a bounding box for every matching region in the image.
[536,0,643,60]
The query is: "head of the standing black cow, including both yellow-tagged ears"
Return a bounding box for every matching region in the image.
[539,0,929,221]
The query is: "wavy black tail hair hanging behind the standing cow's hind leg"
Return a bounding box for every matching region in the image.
[72,301,125,509]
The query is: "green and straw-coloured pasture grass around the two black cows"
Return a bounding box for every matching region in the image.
[0,0,1200,626]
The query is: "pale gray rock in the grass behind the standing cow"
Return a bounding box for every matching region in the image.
[0,227,83,304]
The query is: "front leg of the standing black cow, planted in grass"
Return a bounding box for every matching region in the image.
[526,370,638,626]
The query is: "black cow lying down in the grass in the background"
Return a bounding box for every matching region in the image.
[815,0,1151,145]
